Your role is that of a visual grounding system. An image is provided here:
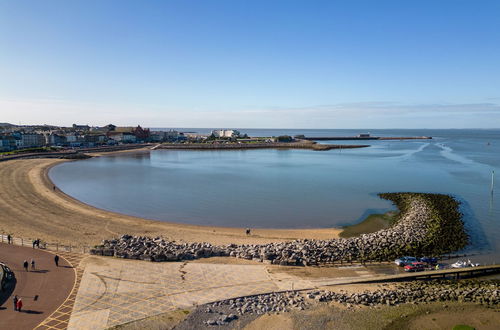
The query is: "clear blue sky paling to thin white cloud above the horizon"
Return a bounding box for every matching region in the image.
[0,0,500,128]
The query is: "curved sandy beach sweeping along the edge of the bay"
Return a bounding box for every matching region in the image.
[0,158,342,245]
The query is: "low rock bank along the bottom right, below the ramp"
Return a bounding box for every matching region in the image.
[195,280,500,326]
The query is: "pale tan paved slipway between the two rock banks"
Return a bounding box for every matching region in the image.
[68,256,373,329]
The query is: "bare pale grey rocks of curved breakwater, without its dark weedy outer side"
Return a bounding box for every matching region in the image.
[90,199,430,265]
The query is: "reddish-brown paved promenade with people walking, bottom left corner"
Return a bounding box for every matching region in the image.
[0,243,75,329]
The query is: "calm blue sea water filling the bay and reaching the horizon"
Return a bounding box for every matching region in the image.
[50,129,500,254]
